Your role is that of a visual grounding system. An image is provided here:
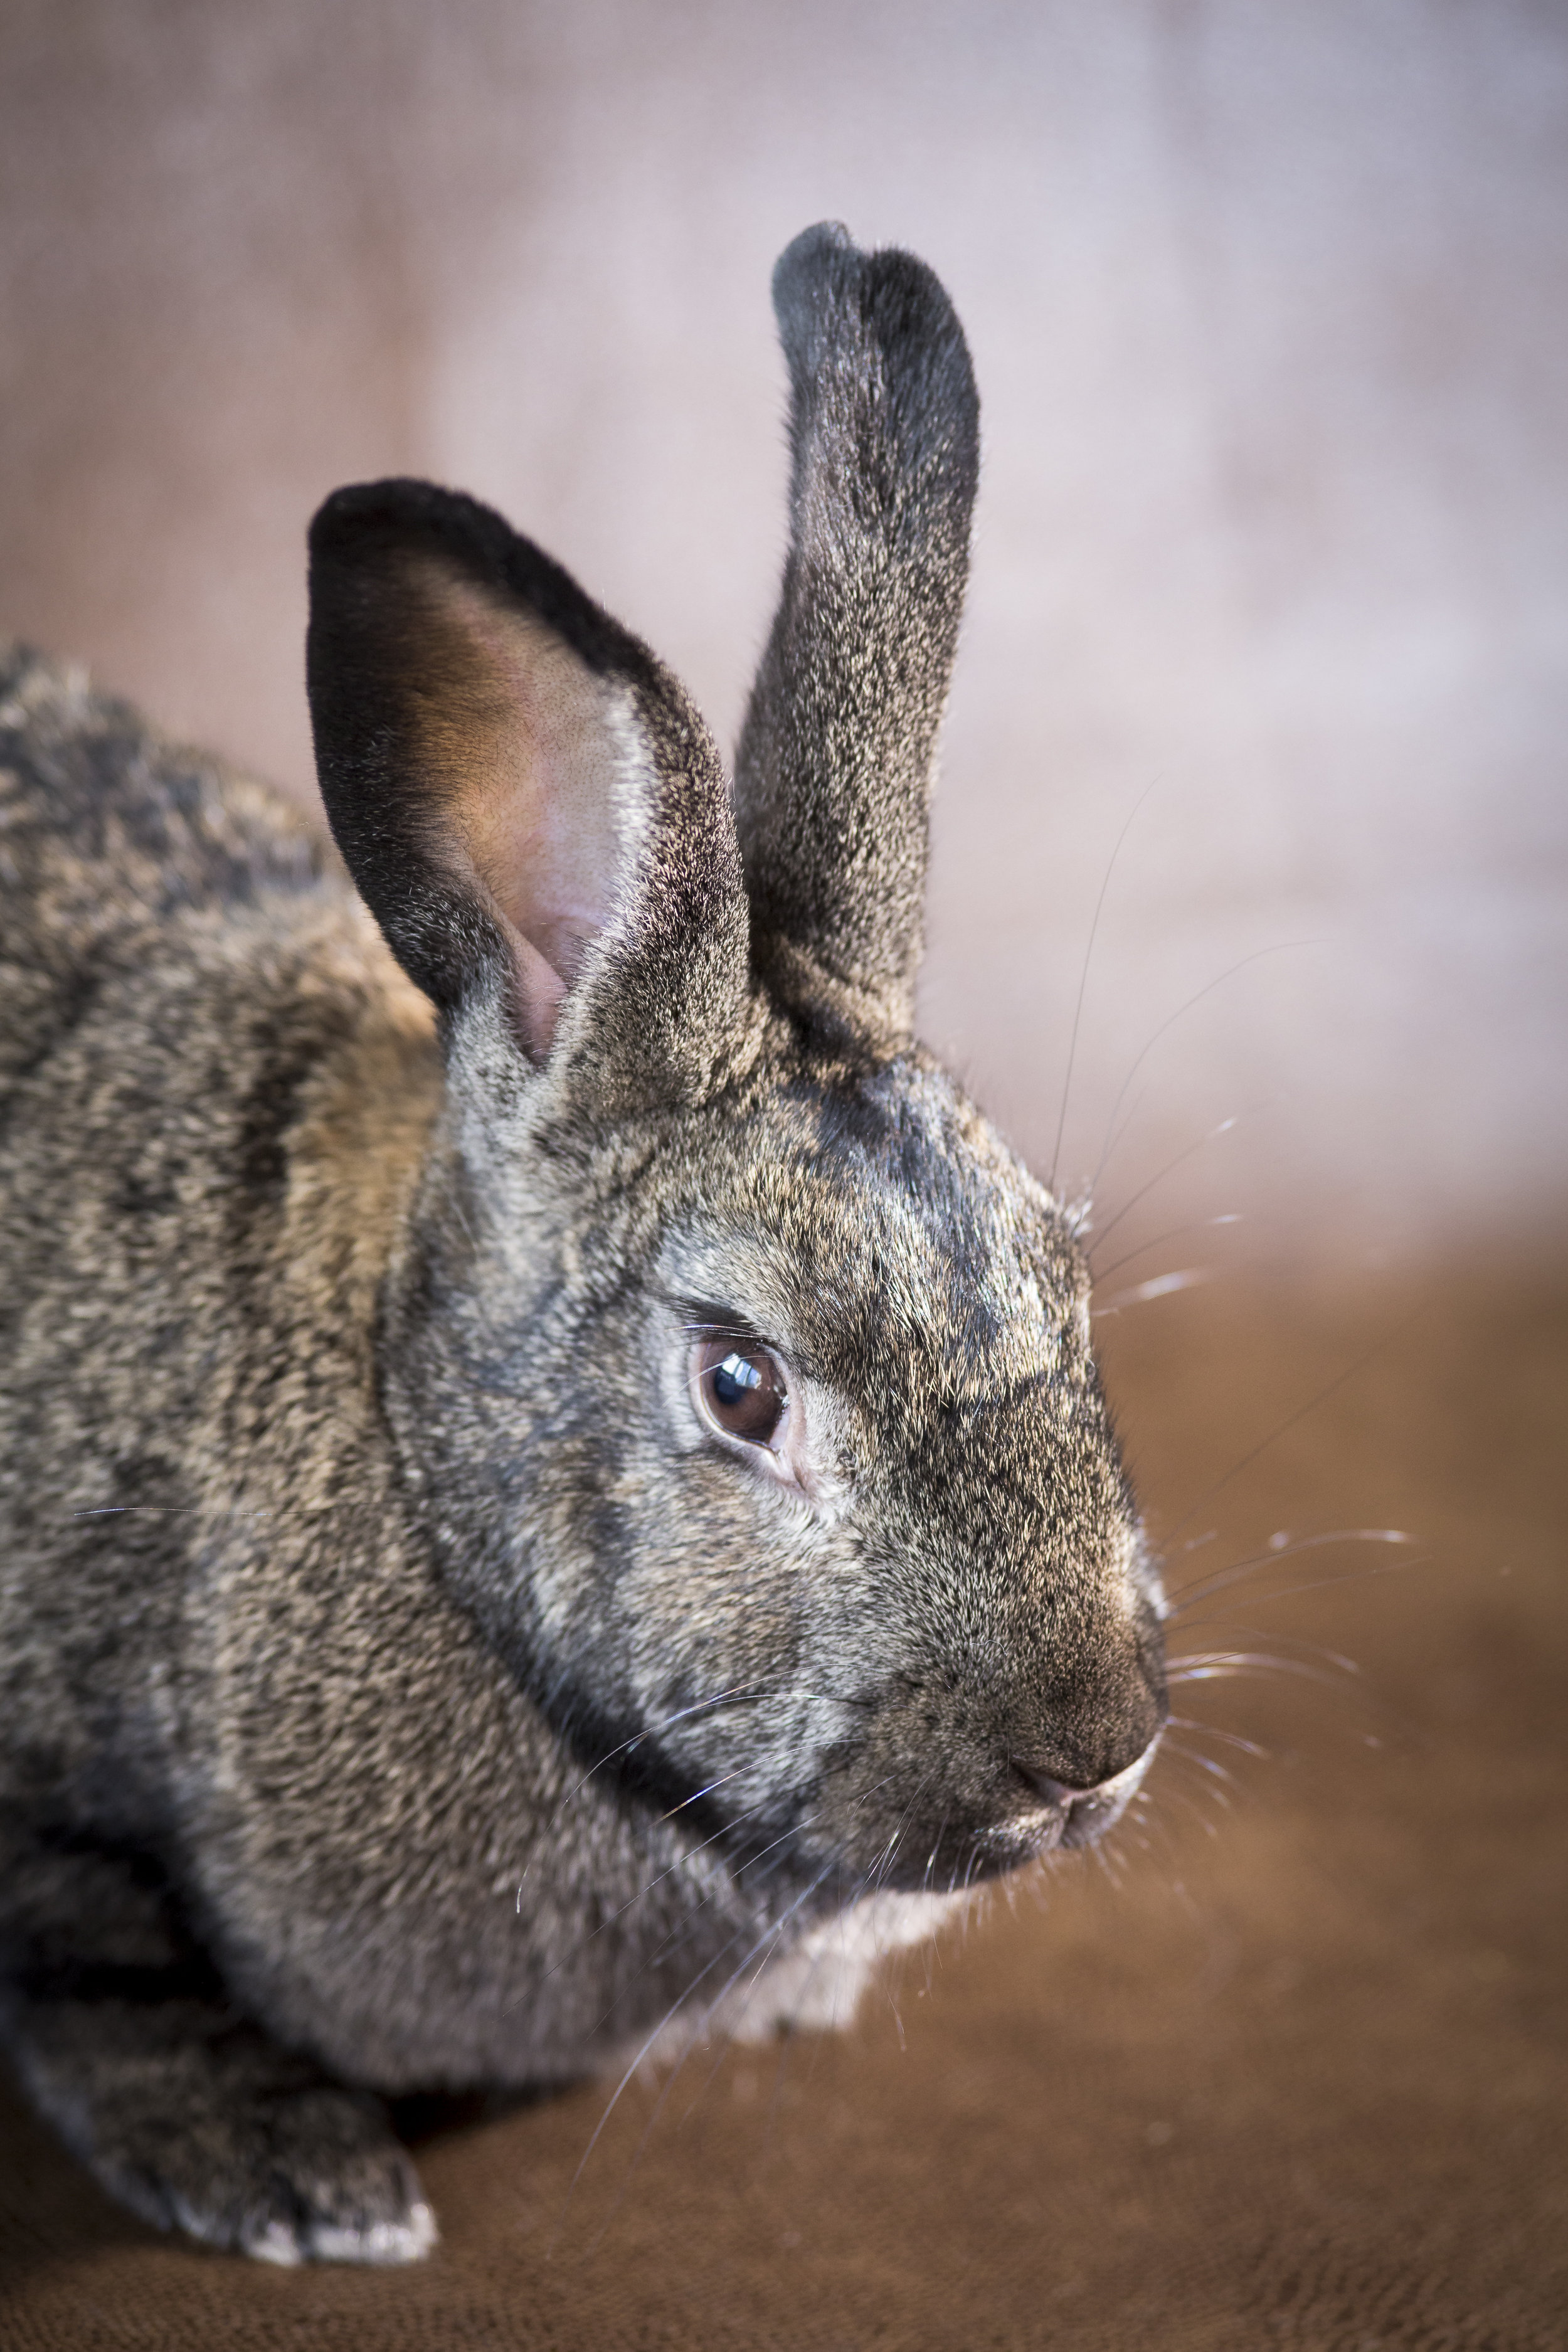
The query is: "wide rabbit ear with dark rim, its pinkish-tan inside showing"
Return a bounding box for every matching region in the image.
[305,482,748,1094]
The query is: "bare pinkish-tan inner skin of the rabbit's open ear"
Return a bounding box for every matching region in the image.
[418,571,621,1059]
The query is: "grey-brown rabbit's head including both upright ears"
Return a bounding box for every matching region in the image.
[308,228,1163,1900]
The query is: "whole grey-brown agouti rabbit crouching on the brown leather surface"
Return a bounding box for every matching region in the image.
[0,226,1166,2263]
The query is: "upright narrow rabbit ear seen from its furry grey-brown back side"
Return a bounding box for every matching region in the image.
[736,223,978,1049]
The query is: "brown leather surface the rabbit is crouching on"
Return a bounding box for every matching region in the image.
[0,1268,1568,2352]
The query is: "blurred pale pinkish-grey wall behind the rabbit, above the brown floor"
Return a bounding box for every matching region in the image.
[0,0,1568,1282]
